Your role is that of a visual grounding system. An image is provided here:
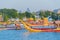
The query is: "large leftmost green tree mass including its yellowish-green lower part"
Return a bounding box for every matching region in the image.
[0,8,18,21]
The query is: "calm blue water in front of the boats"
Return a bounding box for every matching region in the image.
[0,30,60,40]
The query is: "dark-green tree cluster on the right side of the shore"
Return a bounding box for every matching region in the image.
[39,11,60,20]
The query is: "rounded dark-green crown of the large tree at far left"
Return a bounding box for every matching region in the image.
[0,8,18,18]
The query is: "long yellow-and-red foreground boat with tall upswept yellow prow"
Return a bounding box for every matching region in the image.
[20,20,60,32]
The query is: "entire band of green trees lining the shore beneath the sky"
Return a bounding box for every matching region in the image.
[0,8,60,21]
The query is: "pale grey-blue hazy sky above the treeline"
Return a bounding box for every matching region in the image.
[0,0,60,11]
